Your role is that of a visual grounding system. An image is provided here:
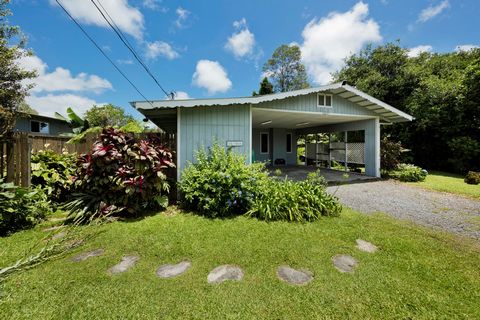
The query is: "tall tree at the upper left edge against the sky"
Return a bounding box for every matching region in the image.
[0,0,36,136]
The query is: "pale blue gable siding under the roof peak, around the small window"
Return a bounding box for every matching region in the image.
[255,93,377,116]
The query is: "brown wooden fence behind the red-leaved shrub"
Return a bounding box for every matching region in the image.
[0,132,177,187]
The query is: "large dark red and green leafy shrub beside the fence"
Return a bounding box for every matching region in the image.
[65,128,174,221]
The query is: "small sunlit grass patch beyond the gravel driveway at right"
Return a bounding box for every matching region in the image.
[408,171,480,199]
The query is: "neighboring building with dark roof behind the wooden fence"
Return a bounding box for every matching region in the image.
[14,114,72,136]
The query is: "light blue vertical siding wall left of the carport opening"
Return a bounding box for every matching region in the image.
[177,105,251,178]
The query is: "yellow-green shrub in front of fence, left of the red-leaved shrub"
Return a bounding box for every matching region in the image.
[31,145,76,202]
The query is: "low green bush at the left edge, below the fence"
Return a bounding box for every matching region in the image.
[0,179,51,236]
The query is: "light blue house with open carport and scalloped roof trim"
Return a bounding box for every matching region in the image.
[131,82,413,177]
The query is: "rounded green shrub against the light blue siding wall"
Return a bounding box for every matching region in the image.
[179,143,268,218]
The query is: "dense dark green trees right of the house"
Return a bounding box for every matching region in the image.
[334,43,480,172]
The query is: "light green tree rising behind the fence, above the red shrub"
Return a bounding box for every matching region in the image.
[85,104,135,128]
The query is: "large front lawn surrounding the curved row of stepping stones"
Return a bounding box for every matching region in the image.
[0,208,480,319]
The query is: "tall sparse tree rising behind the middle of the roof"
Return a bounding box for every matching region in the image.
[263,44,310,92]
